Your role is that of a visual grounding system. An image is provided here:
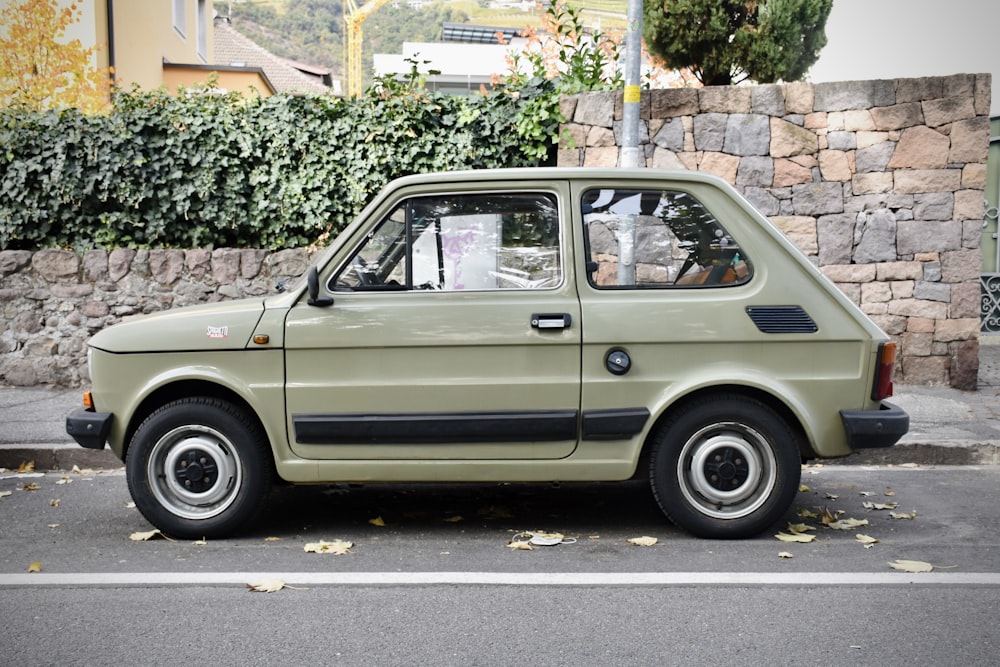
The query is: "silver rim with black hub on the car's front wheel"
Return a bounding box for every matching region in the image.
[146,425,243,519]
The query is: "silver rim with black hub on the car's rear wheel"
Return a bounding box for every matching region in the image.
[677,422,777,519]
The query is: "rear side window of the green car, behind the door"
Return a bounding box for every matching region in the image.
[582,189,751,288]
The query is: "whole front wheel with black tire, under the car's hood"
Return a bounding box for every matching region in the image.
[125,397,271,539]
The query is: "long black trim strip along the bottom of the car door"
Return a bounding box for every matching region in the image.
[292,410,579,445]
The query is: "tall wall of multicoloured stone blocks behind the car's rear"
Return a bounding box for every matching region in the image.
[559,74,991,389]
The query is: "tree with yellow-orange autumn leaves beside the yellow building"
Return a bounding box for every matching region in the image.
[0,0,112,113]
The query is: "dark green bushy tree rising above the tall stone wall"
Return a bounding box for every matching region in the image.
[643,0,833,86]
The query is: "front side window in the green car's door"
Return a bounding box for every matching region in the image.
[334,193,562,291]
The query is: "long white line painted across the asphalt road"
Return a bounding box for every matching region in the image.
[0,572,1000,588]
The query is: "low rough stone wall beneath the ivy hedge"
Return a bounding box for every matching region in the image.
[0,249,310,387]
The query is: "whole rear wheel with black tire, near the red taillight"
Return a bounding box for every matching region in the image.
[650,394,802,539]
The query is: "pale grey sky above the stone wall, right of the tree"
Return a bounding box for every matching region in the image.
[808,0,1000,116]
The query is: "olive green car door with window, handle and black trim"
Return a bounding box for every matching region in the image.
[285,183,581,460]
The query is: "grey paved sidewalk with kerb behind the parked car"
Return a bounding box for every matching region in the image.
[0,338,1000,470]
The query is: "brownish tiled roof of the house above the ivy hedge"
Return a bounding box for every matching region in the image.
[215,18,332,93]
